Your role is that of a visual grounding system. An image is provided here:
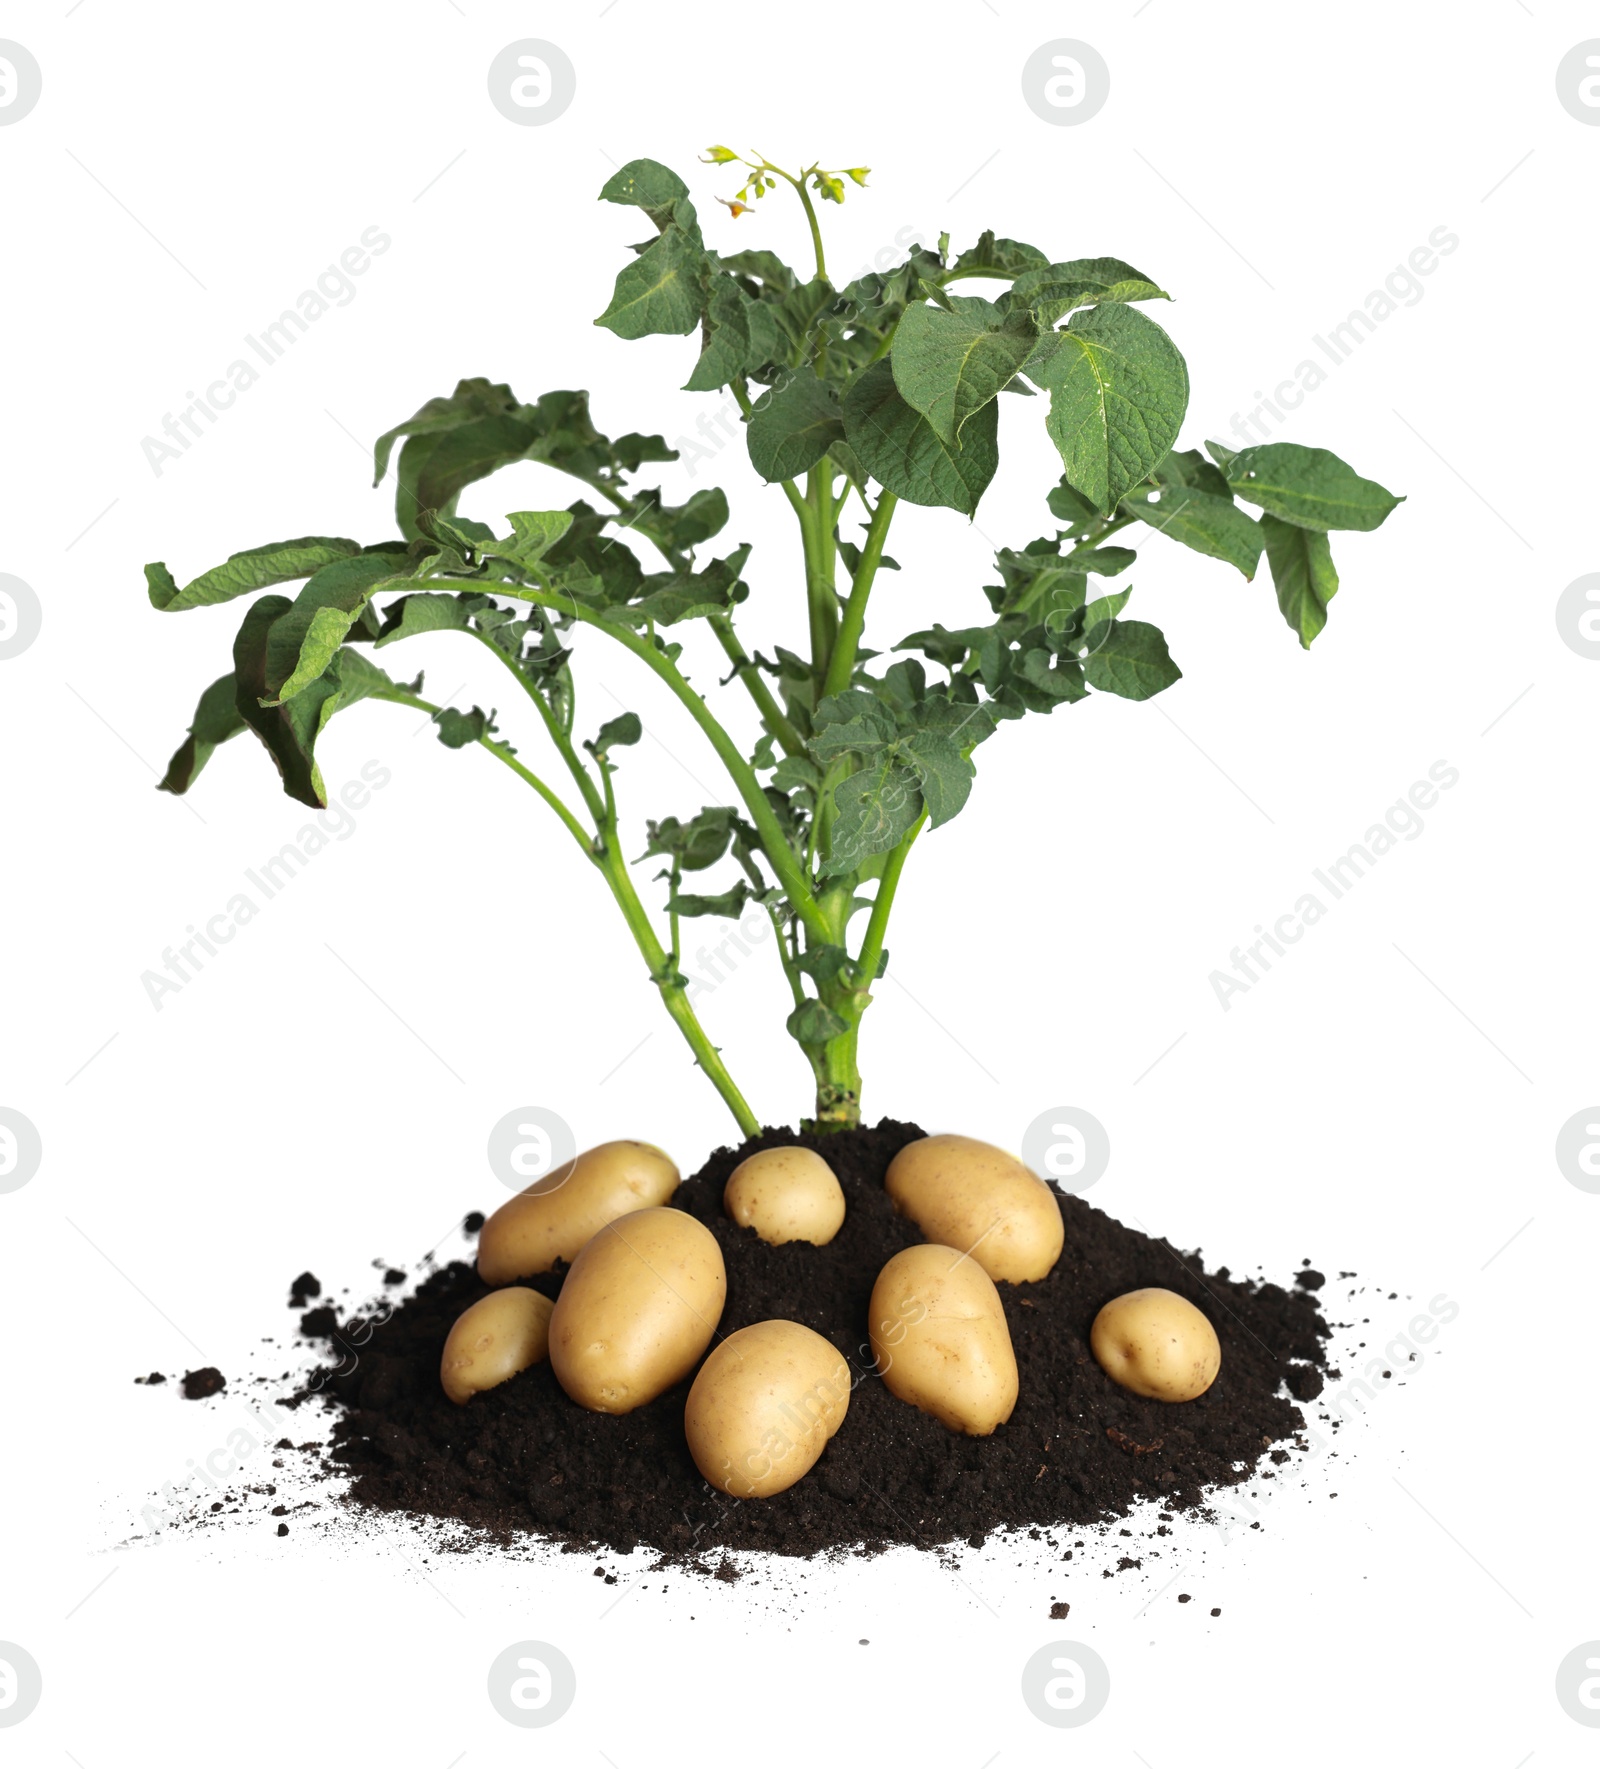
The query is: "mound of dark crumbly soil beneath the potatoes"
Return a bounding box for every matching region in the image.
[296,1120,1327,1560]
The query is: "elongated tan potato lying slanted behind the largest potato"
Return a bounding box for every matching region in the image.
[478,1141,678,1284]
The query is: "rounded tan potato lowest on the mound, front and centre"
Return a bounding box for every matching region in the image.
[683,1321,850,1498]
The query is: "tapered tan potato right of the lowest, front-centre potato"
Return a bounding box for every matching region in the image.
[867,1244,1016,1436]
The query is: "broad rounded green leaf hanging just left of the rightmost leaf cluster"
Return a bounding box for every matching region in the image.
[1028,302,1189,511]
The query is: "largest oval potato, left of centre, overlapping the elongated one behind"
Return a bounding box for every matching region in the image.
[550,1206,727,1413]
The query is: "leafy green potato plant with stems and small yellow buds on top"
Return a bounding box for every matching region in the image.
[145,147,1398,1134]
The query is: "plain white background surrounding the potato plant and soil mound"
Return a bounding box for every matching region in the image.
[0,0,1600,1769]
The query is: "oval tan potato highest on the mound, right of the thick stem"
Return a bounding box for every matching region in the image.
[883,1136,1064,1284]
